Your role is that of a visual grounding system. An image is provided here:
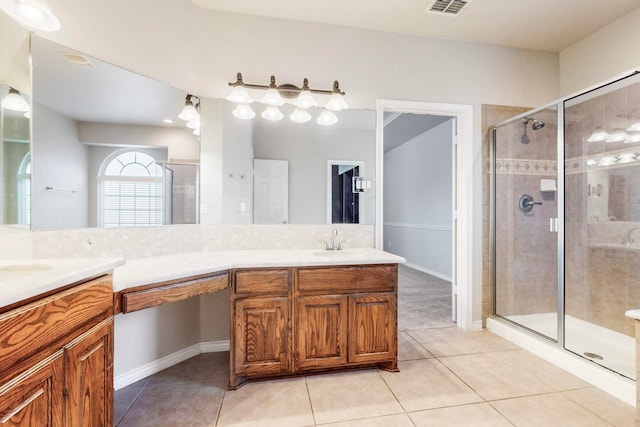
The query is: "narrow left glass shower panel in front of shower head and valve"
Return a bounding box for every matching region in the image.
[492,108,558,340]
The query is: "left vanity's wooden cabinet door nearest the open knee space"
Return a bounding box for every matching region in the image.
[65,318,113,426]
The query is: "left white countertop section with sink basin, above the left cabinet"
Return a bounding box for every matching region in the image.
[0,258,125,307]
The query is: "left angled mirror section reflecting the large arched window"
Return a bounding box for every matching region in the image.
[31,37,199,230]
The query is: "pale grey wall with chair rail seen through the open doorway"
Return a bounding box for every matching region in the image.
[384,120,452,280]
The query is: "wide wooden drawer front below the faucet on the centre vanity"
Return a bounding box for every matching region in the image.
[298,264,398,295]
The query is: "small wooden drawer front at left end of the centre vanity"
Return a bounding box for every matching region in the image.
[234,268,291,297]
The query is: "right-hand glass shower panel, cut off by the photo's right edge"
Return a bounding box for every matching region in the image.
[564,75,640,379]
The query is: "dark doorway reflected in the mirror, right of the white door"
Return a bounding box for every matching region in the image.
[331,165,360,224]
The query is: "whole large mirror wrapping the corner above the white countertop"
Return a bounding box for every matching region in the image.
[20,37,376,230]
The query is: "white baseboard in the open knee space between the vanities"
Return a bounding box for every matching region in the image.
[113,340,229,390]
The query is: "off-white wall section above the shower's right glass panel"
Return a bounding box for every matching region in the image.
[556,8,640,96]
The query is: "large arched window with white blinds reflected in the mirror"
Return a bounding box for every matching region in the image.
[98,150,164,227]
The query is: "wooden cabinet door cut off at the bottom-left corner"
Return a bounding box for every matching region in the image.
[0,351,64,427]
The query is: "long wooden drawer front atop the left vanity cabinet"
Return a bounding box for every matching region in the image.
[0,276,113,376]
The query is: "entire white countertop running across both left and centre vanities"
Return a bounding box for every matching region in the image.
[0,248,405,307]
